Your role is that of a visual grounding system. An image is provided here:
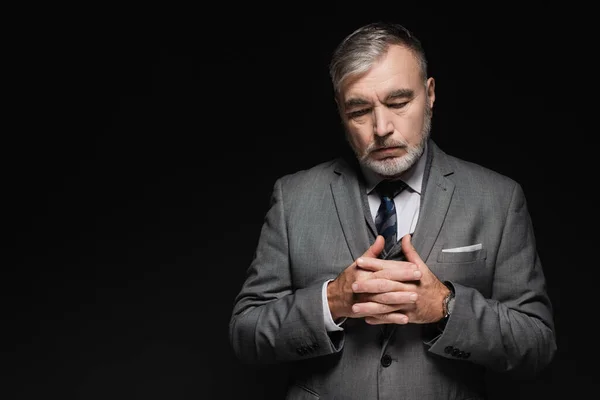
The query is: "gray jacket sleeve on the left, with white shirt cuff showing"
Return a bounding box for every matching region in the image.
[229,179,343,364]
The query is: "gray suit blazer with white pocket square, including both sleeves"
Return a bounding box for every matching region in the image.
[230,140,556,400]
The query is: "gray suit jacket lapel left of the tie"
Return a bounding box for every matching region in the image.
[331,161,370,259]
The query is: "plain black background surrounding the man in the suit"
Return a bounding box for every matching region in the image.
[0,3,599,400]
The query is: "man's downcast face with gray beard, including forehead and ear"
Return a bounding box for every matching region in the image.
[338,46,435,178]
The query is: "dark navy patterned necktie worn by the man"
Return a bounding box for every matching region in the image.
[375,180,406,254]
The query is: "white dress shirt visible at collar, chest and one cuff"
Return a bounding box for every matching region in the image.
[321,148,427,331]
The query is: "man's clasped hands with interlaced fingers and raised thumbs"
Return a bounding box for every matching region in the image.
[327,235,449,325]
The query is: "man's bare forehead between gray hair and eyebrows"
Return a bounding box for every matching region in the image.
[341,45,423,101]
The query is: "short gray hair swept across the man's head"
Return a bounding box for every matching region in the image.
[329,22,427,97]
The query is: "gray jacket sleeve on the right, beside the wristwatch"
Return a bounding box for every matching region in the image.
[429,184,556,377]
